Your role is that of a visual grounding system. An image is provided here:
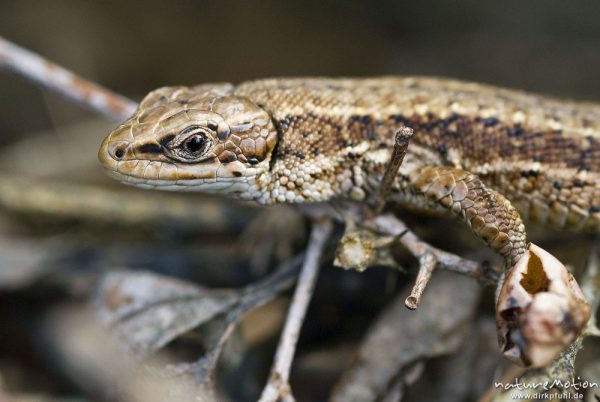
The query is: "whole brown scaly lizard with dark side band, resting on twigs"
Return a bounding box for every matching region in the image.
[99,77,600,267]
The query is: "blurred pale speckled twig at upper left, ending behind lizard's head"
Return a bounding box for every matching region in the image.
[0,37,136,121]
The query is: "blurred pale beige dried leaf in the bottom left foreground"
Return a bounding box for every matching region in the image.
[49,309,214,402]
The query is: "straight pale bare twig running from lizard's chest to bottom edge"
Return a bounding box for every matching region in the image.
[260,220,333,402]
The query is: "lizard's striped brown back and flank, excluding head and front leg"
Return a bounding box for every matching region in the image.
[234,77,600,232]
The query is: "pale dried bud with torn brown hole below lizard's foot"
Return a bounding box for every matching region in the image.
[496,243,590,367]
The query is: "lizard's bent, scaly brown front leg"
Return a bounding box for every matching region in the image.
[409,166,526,269]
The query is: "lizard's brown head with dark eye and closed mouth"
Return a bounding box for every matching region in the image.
[98,84,277,199]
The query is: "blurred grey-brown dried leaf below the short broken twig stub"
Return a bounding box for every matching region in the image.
[331,272,479,402]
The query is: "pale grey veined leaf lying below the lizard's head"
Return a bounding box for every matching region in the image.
[96,271,240,356]
